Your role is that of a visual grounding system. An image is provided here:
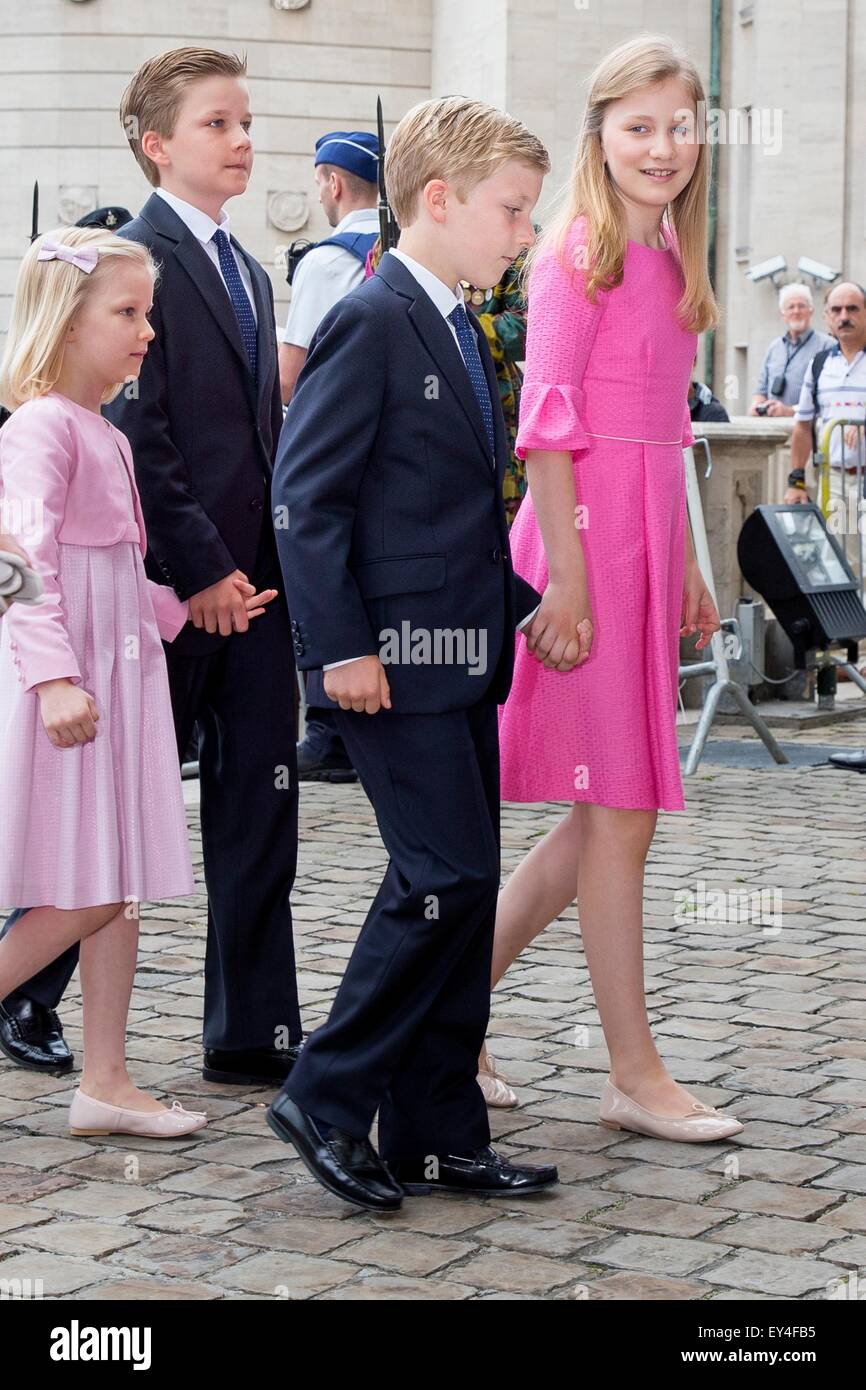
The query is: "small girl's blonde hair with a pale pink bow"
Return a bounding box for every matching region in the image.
[0,227,157,410]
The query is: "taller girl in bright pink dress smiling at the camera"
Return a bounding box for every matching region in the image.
[481,36,742,1143]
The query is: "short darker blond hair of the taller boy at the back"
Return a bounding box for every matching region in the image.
[121,49,246,188]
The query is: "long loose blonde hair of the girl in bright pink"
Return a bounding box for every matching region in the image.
[524,35,719,334]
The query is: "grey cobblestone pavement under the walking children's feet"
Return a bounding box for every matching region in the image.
[0,723,866,1301]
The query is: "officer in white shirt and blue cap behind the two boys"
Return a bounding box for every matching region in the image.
[279,131,379,781]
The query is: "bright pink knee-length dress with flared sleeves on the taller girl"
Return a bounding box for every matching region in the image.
[499,218,696,810]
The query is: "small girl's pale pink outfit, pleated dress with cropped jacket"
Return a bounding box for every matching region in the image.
[0,393,195,922]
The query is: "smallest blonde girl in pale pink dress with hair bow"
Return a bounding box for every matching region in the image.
[0,228,274,1138]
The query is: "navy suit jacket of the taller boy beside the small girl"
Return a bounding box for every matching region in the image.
[103,193,282,655]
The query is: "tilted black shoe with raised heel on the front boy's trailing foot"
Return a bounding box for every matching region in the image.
[267,1095,403,1212]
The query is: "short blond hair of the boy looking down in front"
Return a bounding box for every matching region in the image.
[385,96,550,227]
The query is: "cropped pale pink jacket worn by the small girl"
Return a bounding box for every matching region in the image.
[0,391,189,689]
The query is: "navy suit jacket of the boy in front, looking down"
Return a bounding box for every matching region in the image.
[272,254,541,713]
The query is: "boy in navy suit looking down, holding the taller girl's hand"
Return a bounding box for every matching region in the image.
[268,97,569,1209]
